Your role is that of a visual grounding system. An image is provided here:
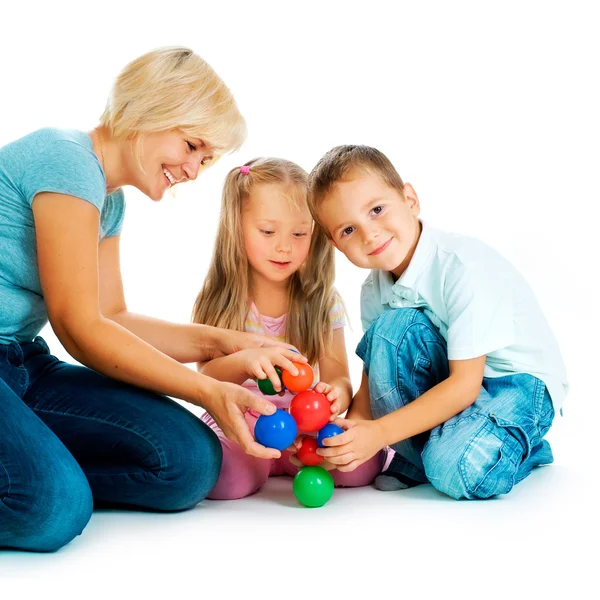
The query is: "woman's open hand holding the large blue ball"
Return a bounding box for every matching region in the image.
[202,380,281,459]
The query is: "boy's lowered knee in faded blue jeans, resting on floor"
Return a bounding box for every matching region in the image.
[422,414,523,500]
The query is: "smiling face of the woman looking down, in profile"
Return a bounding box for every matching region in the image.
[132,130,213,201]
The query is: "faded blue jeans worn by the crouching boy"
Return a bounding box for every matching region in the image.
[356,308,554,499]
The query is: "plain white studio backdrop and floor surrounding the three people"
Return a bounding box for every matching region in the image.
[0,0,600,598]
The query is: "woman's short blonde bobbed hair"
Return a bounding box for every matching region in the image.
[100,47,246,165]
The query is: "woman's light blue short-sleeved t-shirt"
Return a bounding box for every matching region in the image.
[0,128,125,344]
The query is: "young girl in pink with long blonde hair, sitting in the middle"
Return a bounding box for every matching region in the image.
[193,158,386,500]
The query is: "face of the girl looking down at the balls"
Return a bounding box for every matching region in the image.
[242,184,313,282]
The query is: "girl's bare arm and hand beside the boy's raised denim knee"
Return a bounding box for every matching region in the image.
[315,327,352,417]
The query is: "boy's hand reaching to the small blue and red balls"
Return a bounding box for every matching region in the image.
[317,419,385,472]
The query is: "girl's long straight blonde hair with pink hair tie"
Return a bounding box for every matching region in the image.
[192,158,335,365]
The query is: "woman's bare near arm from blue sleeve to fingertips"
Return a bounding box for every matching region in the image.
[32,193,279,458]
